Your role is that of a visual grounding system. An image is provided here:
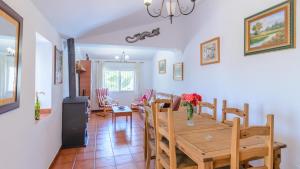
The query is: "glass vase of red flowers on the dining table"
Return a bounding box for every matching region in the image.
[182,93,202,126]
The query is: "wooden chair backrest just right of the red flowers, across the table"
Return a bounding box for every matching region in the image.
[198,98,217,120]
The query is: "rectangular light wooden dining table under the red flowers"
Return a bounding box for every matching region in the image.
[161,111,286,169]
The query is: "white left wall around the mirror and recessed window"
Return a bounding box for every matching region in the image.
[0,0,63,169]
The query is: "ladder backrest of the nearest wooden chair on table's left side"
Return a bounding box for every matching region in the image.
[155,99,177,169]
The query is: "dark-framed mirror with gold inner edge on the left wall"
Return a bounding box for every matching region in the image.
[0,0,23,114]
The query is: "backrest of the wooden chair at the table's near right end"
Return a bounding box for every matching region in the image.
[230,115,274,169]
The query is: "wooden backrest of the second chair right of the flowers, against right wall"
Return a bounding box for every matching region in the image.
[222,100,249,128]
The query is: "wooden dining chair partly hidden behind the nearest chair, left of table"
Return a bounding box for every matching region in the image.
[144,102,156,169]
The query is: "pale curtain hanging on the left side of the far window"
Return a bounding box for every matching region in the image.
[91,60,103,110]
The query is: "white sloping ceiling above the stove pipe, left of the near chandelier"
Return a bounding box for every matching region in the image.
[32,0,198,38]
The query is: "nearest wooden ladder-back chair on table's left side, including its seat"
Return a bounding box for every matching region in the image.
[155,100,198,169]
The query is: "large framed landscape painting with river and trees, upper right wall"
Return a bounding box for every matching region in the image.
[245,0,296,55]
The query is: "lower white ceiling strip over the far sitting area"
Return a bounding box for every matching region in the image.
[76,44,158,60]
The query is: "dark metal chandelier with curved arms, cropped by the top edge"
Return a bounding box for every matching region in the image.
[144,0,196,24]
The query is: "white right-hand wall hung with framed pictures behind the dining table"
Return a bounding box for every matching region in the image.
[153,0,300,169]
